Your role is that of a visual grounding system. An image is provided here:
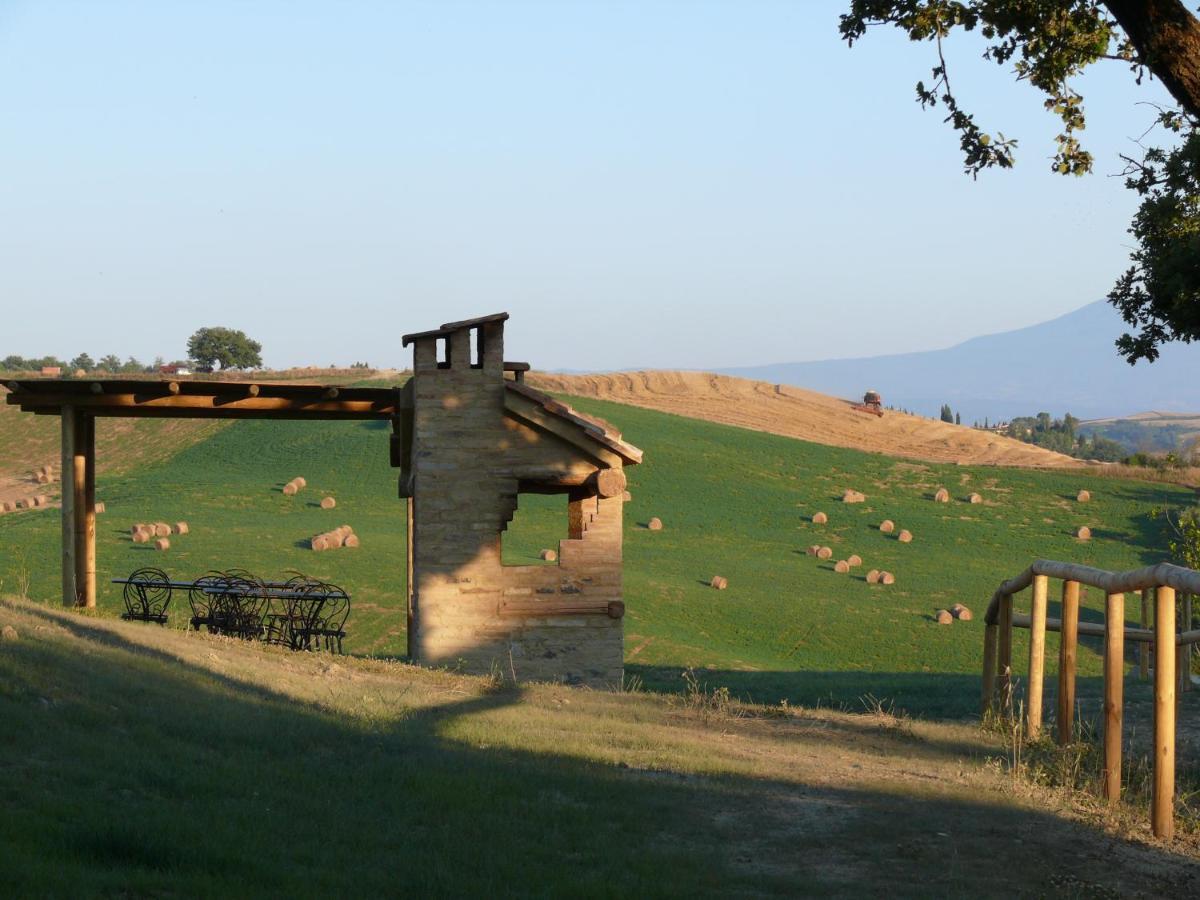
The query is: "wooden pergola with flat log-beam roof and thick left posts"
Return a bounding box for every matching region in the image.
[6,378,400,606]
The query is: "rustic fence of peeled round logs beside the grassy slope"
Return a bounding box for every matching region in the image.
[982,559,1200,840]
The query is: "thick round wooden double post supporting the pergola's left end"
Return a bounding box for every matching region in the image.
[61,406,96,607]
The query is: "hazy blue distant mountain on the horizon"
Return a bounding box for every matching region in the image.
[718,301,1200,424]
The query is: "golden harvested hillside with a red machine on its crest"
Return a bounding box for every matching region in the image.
[529,372,1080,468]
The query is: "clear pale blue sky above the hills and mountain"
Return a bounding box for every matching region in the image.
[0,0,1166,370]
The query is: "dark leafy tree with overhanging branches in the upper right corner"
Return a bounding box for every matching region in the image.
[840,0,1200,365]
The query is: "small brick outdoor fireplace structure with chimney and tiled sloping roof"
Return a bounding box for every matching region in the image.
[392,313,642,685]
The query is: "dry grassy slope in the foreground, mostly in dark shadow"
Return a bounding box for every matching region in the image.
[0,601,1195,896]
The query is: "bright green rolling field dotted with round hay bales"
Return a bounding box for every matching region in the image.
[0,400,1192,716]
